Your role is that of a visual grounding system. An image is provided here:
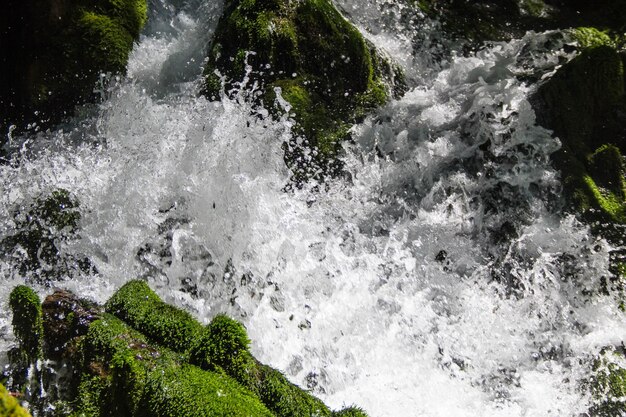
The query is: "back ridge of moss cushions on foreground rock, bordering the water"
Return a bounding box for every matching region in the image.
[106,280,346,417]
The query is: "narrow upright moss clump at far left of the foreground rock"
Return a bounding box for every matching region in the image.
[9,285,43,361]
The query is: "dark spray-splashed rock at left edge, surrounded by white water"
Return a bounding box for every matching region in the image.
[0,189,93,283]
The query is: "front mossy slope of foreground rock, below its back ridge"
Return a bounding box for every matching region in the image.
[70,315,271,417]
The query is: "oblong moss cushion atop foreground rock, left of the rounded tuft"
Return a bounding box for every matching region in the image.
[105,280,202,352]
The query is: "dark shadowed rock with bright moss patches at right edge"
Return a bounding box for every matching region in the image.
[534,43,626,223]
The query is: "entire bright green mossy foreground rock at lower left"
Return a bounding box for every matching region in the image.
[11,281,366,417]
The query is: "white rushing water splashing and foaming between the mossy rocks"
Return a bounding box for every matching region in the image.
[0,0,626,417]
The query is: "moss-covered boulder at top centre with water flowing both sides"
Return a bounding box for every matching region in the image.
[203,0,405,180]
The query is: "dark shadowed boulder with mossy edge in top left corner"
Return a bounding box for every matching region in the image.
[0,0,147,139]
